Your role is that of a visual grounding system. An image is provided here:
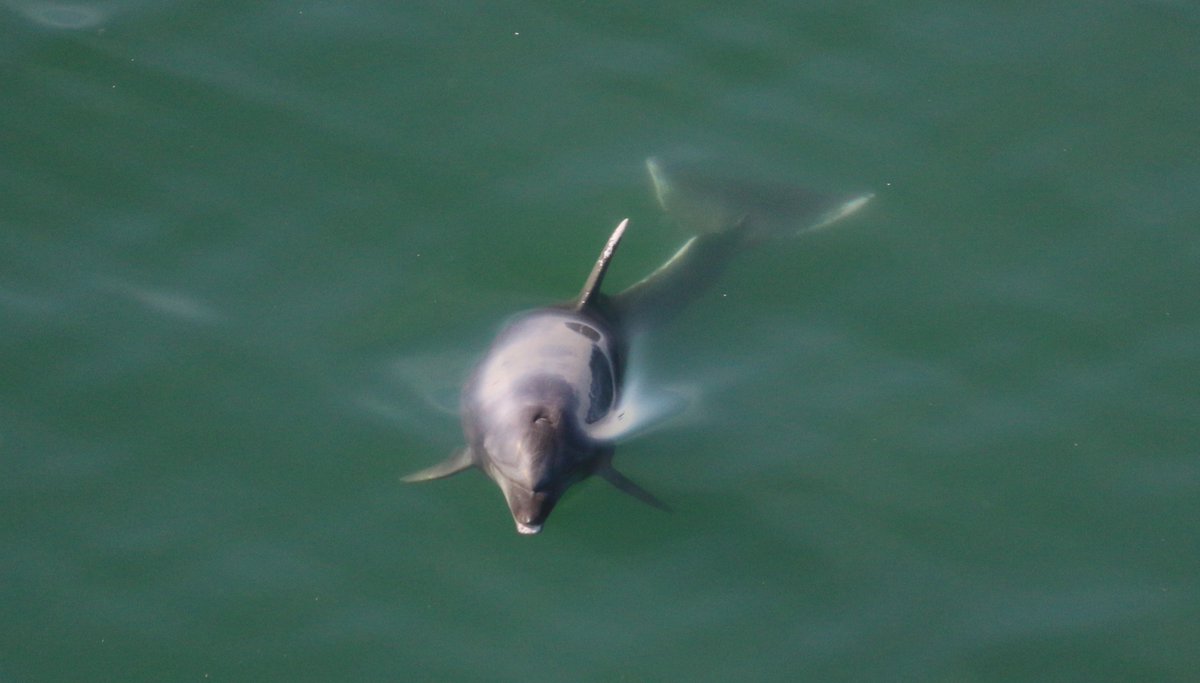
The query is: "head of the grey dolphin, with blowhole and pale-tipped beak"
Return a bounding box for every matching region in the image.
[477,379,595,534]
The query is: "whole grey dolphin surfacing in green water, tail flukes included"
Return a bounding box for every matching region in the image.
[403,158,871,534]
